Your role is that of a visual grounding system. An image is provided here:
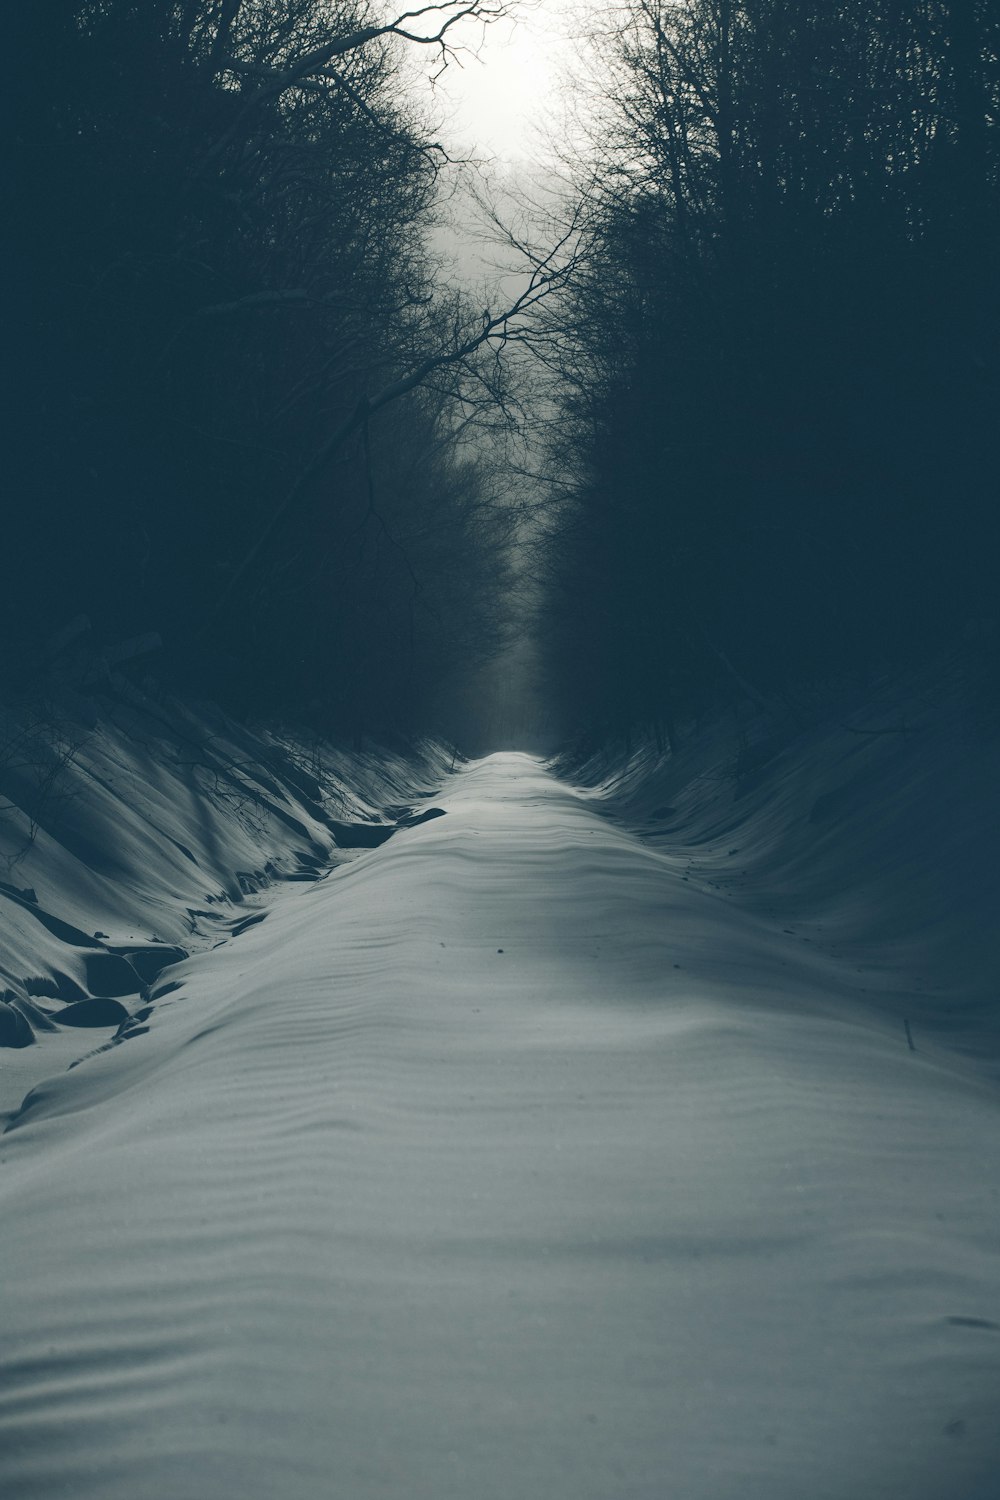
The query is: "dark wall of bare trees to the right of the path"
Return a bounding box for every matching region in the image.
[541,0,1000,734]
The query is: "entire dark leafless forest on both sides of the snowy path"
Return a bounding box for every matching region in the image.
[7,0,1000,741]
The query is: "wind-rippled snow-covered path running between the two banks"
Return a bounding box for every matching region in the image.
[0,753,1000,1500]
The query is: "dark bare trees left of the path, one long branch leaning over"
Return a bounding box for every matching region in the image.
[9,0,510,729]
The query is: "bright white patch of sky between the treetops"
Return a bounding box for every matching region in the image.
[438,0,571,162]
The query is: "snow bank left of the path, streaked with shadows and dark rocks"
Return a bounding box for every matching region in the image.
[0,680,450,1119]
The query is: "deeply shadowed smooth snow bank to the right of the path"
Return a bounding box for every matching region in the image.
[566,669,1000,1077]
